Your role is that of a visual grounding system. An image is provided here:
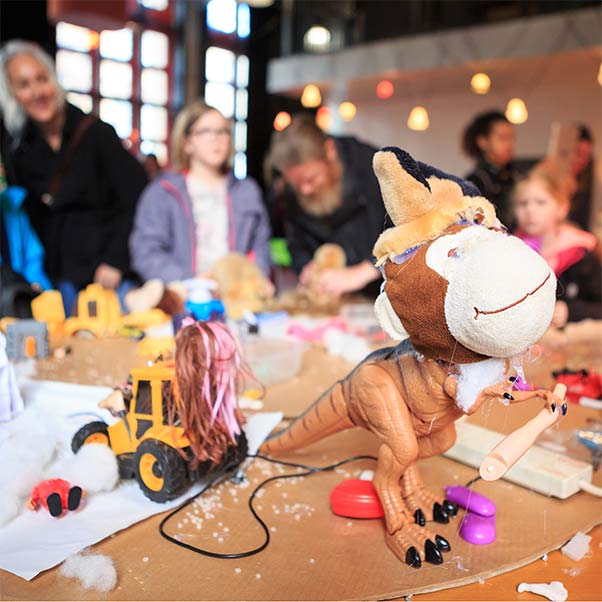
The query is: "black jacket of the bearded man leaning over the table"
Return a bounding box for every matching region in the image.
[285,137,386,294]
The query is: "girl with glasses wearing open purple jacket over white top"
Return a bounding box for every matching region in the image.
[130,100,270,292]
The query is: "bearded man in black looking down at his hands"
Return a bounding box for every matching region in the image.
[265,115,386,297]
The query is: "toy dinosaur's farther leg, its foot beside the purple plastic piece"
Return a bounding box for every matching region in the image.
[401,424,458,525]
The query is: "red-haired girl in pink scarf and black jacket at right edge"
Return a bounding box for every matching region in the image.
[514,164,602,328]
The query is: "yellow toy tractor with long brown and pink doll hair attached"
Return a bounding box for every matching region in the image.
[71,322,250,502]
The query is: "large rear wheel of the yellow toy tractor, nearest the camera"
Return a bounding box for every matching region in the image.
[135,439,189,502]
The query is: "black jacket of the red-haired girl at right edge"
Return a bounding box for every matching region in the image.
[556,248,602,322]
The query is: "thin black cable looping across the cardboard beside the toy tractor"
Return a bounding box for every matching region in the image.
[159,454,376,559]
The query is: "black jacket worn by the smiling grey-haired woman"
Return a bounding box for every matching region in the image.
[13,103,147,288]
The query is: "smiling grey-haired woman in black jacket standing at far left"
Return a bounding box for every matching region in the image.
[0,40,147,314]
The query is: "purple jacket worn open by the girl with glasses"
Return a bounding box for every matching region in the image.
[130,172,270,282]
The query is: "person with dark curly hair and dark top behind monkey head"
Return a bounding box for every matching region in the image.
[462,111,515,227]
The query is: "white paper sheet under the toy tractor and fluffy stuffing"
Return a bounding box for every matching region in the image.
[0,381,282,581]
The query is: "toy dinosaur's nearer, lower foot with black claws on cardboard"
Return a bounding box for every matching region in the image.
[386,524,451,569]
